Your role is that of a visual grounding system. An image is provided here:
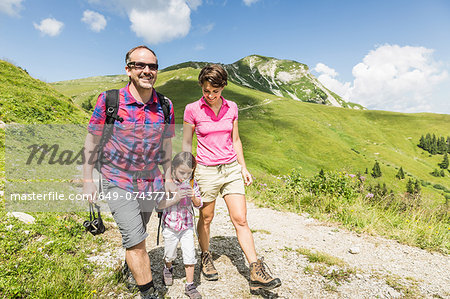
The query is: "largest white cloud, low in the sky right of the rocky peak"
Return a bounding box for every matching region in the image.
[314,45,448,112]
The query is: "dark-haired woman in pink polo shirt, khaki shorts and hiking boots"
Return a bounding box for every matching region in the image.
[183,64,281,292]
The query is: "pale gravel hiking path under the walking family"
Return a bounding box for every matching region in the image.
[91,199,450,298]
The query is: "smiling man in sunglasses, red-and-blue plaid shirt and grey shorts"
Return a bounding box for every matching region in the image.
[83,46,175,298]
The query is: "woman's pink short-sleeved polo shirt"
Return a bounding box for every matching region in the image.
[184,97,238,166]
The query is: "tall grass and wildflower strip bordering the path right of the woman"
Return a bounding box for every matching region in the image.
[247,171,450,254]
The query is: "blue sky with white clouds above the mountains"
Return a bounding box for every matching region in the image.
[0,0,450,114]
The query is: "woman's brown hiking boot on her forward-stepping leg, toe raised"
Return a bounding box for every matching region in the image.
[250,257,281,294]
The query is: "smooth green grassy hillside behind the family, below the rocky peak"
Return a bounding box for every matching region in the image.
[54,67,450,200]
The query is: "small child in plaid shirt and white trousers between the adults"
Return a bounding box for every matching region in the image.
[158,152,202,299]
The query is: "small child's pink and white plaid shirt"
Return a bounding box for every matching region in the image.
[162,180,203,231]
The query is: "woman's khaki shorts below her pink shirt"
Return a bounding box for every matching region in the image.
[195,161,245,202]
